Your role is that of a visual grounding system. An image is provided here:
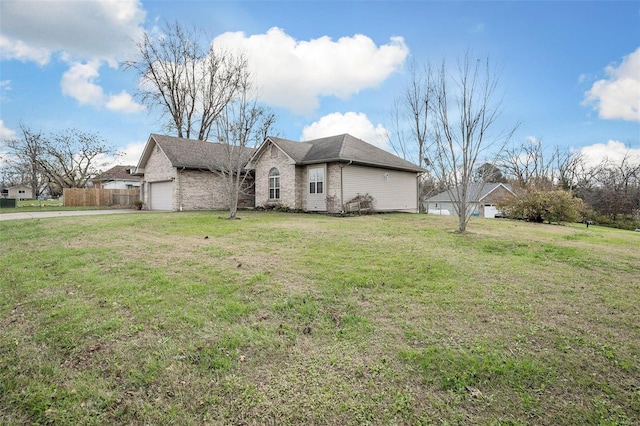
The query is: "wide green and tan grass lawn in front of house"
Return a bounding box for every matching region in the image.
[0,212,640,425]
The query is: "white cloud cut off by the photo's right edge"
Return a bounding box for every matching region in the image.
[582,47,640,122]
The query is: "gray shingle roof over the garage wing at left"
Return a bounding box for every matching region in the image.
[151,134,255,169]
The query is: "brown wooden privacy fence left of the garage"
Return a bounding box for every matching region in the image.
[62,188,140,207]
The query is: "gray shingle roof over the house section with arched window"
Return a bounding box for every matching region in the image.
[269,134,425,173]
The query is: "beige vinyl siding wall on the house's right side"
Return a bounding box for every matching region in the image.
[342,166,418,213]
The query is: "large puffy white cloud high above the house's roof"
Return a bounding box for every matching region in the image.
[213,27,409,114]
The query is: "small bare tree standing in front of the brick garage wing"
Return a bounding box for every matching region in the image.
[210,70,275,219]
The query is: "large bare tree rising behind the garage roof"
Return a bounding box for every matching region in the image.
[125,23,247,140]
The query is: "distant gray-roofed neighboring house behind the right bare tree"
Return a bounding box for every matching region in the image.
[424,183,516,218]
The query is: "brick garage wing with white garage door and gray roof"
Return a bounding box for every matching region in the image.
[135,134,255,211]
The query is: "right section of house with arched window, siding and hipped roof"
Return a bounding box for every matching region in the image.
[247,134,424,213]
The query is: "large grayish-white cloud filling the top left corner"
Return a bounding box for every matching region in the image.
[0,0,145,64]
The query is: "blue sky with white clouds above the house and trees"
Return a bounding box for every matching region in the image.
[0,0,640,168]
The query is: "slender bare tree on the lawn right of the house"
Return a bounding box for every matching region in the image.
[430,52,517,232]
